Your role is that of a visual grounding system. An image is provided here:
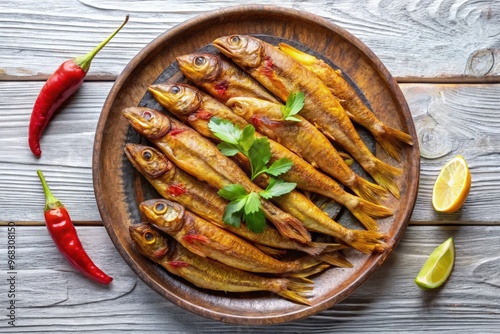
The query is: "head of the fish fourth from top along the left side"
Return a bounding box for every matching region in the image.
[122,107,172,139]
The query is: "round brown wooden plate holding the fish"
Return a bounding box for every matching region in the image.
[93,5,420,324]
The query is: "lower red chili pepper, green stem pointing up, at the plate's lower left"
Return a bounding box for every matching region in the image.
[37,170,113,284]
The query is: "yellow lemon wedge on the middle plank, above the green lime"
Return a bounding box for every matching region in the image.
[432,155,471,213]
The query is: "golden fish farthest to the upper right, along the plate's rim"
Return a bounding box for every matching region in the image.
[279,43,413,161]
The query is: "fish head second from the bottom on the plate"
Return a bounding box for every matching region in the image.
[139,199,184,233]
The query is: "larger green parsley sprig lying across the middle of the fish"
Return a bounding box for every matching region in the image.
[208,117,296,233]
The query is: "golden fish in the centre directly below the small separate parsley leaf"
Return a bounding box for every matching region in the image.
[227,97,387,203]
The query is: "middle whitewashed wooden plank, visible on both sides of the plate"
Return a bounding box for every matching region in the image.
[0,82,500,224]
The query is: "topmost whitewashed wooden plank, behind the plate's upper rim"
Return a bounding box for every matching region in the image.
[0,0,500,81]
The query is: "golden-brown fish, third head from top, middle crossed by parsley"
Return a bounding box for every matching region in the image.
[149,83,391,230]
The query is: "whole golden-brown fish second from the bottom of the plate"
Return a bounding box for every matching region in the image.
[139,199,330,274]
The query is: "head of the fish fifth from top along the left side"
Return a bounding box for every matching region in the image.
[124,143,175,179]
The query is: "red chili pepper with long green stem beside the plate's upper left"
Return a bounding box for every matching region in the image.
[28,15,129,157]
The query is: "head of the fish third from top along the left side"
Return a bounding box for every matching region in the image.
[148,83,203,118]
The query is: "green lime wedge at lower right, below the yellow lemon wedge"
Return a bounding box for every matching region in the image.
[415,238,455,289]
